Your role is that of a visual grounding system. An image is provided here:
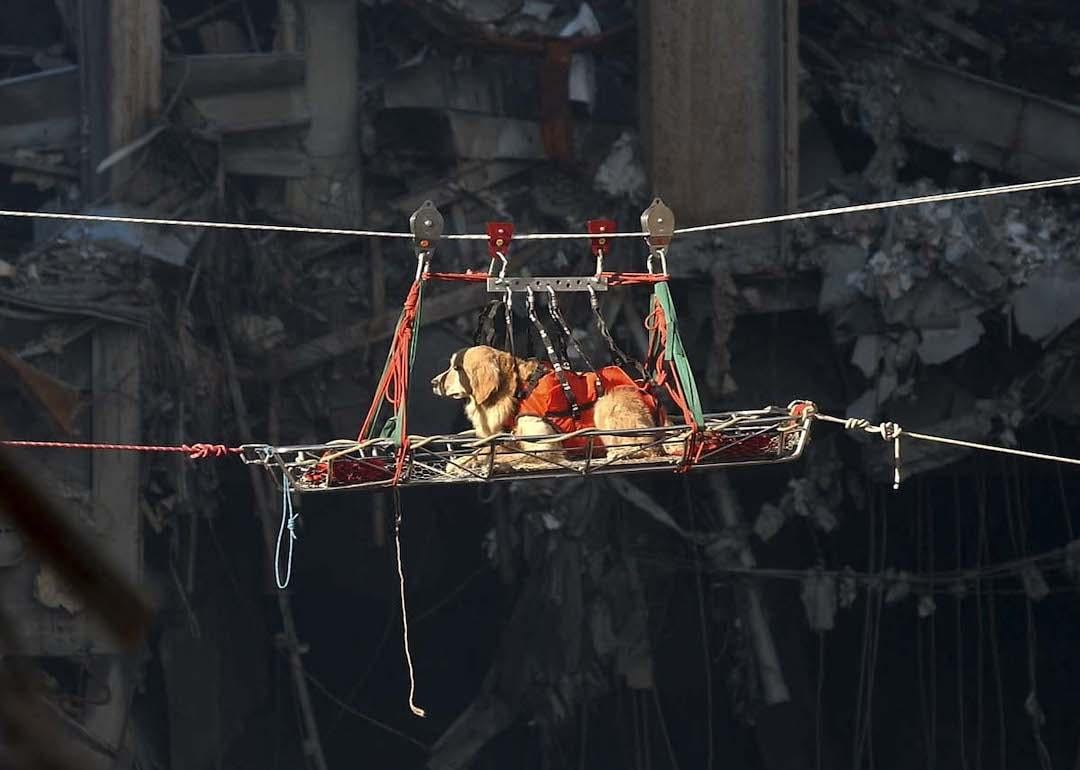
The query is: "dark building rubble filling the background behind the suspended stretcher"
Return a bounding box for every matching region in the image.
[0,0,1080,770]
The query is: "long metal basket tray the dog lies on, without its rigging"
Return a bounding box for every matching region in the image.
[241,407,813,492]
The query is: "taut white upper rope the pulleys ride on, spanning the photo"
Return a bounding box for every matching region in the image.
[0,176,1080,241]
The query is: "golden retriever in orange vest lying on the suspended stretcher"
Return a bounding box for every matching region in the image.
[431,346,666,466]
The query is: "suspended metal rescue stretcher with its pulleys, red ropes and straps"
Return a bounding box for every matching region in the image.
[241,199,815,491]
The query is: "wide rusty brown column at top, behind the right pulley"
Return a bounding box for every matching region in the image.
[639,0,798,225]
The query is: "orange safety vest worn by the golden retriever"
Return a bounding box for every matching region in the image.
[517,366,661,457]
